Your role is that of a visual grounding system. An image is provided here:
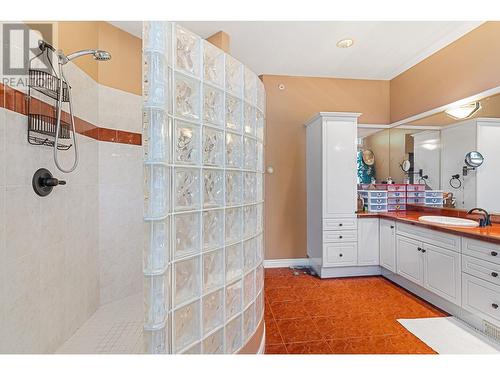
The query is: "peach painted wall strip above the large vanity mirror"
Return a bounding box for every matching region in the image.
[390,21,500,122]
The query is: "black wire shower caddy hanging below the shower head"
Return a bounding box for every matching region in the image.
[26,43,72,150]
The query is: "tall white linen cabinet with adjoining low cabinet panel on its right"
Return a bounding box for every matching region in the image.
[306,112,380,278]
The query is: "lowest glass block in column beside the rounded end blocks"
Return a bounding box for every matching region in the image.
[172,301,201,353]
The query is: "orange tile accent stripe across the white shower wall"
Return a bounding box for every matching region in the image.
[0,83,142,146]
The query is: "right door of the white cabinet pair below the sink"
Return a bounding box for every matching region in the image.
[423,244,462,305]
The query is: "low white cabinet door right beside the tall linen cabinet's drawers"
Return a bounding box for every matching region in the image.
[358,218,379,266]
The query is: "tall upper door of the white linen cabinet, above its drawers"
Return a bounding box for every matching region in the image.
[323,119,357,218]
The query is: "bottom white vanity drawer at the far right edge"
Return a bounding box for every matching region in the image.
[462,273,500,324]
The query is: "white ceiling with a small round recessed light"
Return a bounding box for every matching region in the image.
[111,21,481,80]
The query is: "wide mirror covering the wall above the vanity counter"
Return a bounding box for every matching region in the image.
[358,94,500,212]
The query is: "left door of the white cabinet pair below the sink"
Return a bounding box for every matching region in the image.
[396,236,424,285]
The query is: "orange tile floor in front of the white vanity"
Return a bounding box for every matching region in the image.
[265,268,447,354]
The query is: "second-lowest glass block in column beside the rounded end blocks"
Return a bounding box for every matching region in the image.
[174,257,201,306]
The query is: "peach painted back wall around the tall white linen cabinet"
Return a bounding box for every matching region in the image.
[261,75,389,259]
